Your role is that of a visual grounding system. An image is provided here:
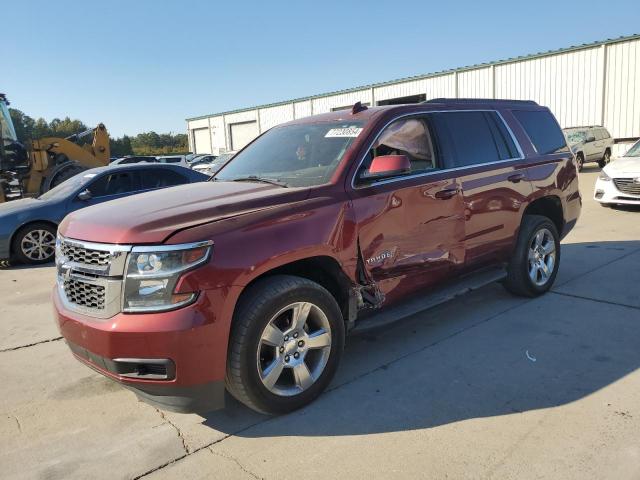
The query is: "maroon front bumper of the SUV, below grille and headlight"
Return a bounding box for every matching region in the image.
[53,287,228,412]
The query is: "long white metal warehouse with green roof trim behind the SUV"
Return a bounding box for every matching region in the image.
[187,35,640,155]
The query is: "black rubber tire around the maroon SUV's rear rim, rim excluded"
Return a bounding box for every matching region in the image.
[504,215,560,297]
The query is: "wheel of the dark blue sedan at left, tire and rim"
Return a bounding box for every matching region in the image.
[12,222,56,265]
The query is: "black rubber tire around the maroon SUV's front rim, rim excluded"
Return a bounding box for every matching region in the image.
[226,275,345,414]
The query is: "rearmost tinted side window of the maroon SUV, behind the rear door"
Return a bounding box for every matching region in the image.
[513,110,568,155]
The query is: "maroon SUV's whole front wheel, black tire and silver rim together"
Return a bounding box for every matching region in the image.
[226,275,345,414]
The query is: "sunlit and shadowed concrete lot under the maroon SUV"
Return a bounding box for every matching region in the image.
[0,168,640,480]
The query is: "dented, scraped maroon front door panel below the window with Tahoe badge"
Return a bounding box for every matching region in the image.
[353,173,465,303]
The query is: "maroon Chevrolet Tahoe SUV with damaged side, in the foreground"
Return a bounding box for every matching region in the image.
[53,99,581,413]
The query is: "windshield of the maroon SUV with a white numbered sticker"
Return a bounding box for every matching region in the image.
[213,122,362,187]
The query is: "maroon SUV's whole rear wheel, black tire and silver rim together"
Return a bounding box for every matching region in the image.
[505,215,560,297]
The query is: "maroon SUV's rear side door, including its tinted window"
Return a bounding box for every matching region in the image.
[433,110,533,269]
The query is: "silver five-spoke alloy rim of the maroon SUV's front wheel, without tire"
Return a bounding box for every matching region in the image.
[257,302,331,396]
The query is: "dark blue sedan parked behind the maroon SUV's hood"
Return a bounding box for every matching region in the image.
[0,164,209,264]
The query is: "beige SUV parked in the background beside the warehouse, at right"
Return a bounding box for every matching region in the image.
[564,126,614,171]
